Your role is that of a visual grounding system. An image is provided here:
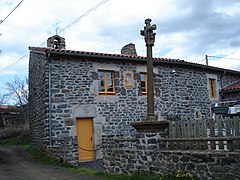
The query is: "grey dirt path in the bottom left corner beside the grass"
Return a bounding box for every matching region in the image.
[0,146,100,180]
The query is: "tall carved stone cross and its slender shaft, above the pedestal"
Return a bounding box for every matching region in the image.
[140,19,157,121]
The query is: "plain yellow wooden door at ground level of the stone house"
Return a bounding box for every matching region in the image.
[76,119,94,161]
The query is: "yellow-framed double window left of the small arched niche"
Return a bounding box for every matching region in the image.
[98,70,115,95]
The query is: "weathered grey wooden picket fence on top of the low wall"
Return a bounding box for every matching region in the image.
[161,115,240,151]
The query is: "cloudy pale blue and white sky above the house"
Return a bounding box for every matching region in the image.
[0,0,240,98]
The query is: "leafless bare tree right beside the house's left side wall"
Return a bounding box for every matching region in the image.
[6,76,28,125]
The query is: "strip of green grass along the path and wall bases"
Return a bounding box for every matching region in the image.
[0,135,199,180]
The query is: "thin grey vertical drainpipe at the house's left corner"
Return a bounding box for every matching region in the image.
[47,54,52,147]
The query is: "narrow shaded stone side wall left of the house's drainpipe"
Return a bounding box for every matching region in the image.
[29,53,49,150]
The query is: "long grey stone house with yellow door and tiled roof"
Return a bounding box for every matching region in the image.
[29,35,240,164]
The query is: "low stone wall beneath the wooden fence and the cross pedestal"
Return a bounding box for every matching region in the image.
[102,133,240,179]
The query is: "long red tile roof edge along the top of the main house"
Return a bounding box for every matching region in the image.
[29,47,240,75]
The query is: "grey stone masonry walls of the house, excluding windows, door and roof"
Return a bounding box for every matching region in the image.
[29,51,238,165]
